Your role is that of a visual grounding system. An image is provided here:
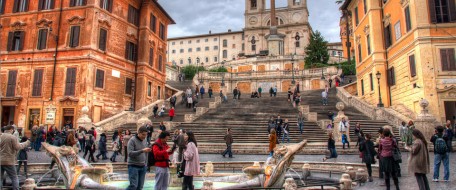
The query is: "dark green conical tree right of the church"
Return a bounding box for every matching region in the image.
[305,30,329,65]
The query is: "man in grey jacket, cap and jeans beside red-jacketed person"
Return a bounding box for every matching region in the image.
[125,126,152,190]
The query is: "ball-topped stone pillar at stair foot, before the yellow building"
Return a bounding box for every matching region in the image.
[415,99,438,137]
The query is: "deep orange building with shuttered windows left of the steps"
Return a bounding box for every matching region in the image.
[0,0,174,132]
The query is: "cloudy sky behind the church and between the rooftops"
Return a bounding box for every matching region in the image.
[158,0,340,42]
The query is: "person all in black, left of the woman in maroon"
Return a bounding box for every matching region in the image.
[359,134,377,182]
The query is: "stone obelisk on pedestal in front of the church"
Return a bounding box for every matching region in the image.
[266,0,285,56]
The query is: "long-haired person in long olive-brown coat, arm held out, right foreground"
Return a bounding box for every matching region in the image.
[405,129,431,190]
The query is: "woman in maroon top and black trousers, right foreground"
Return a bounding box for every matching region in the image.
[378,128,399,190]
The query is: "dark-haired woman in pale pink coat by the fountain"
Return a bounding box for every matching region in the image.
[182,131,200,190]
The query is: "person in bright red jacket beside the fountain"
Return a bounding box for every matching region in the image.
[149,131,174,190]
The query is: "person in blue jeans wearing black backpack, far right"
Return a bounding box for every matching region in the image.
[431,126,450,182]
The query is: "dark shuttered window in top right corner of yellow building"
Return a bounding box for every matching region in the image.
[429,0,456,23]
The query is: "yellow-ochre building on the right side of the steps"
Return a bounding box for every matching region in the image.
[341,0,456,122]
